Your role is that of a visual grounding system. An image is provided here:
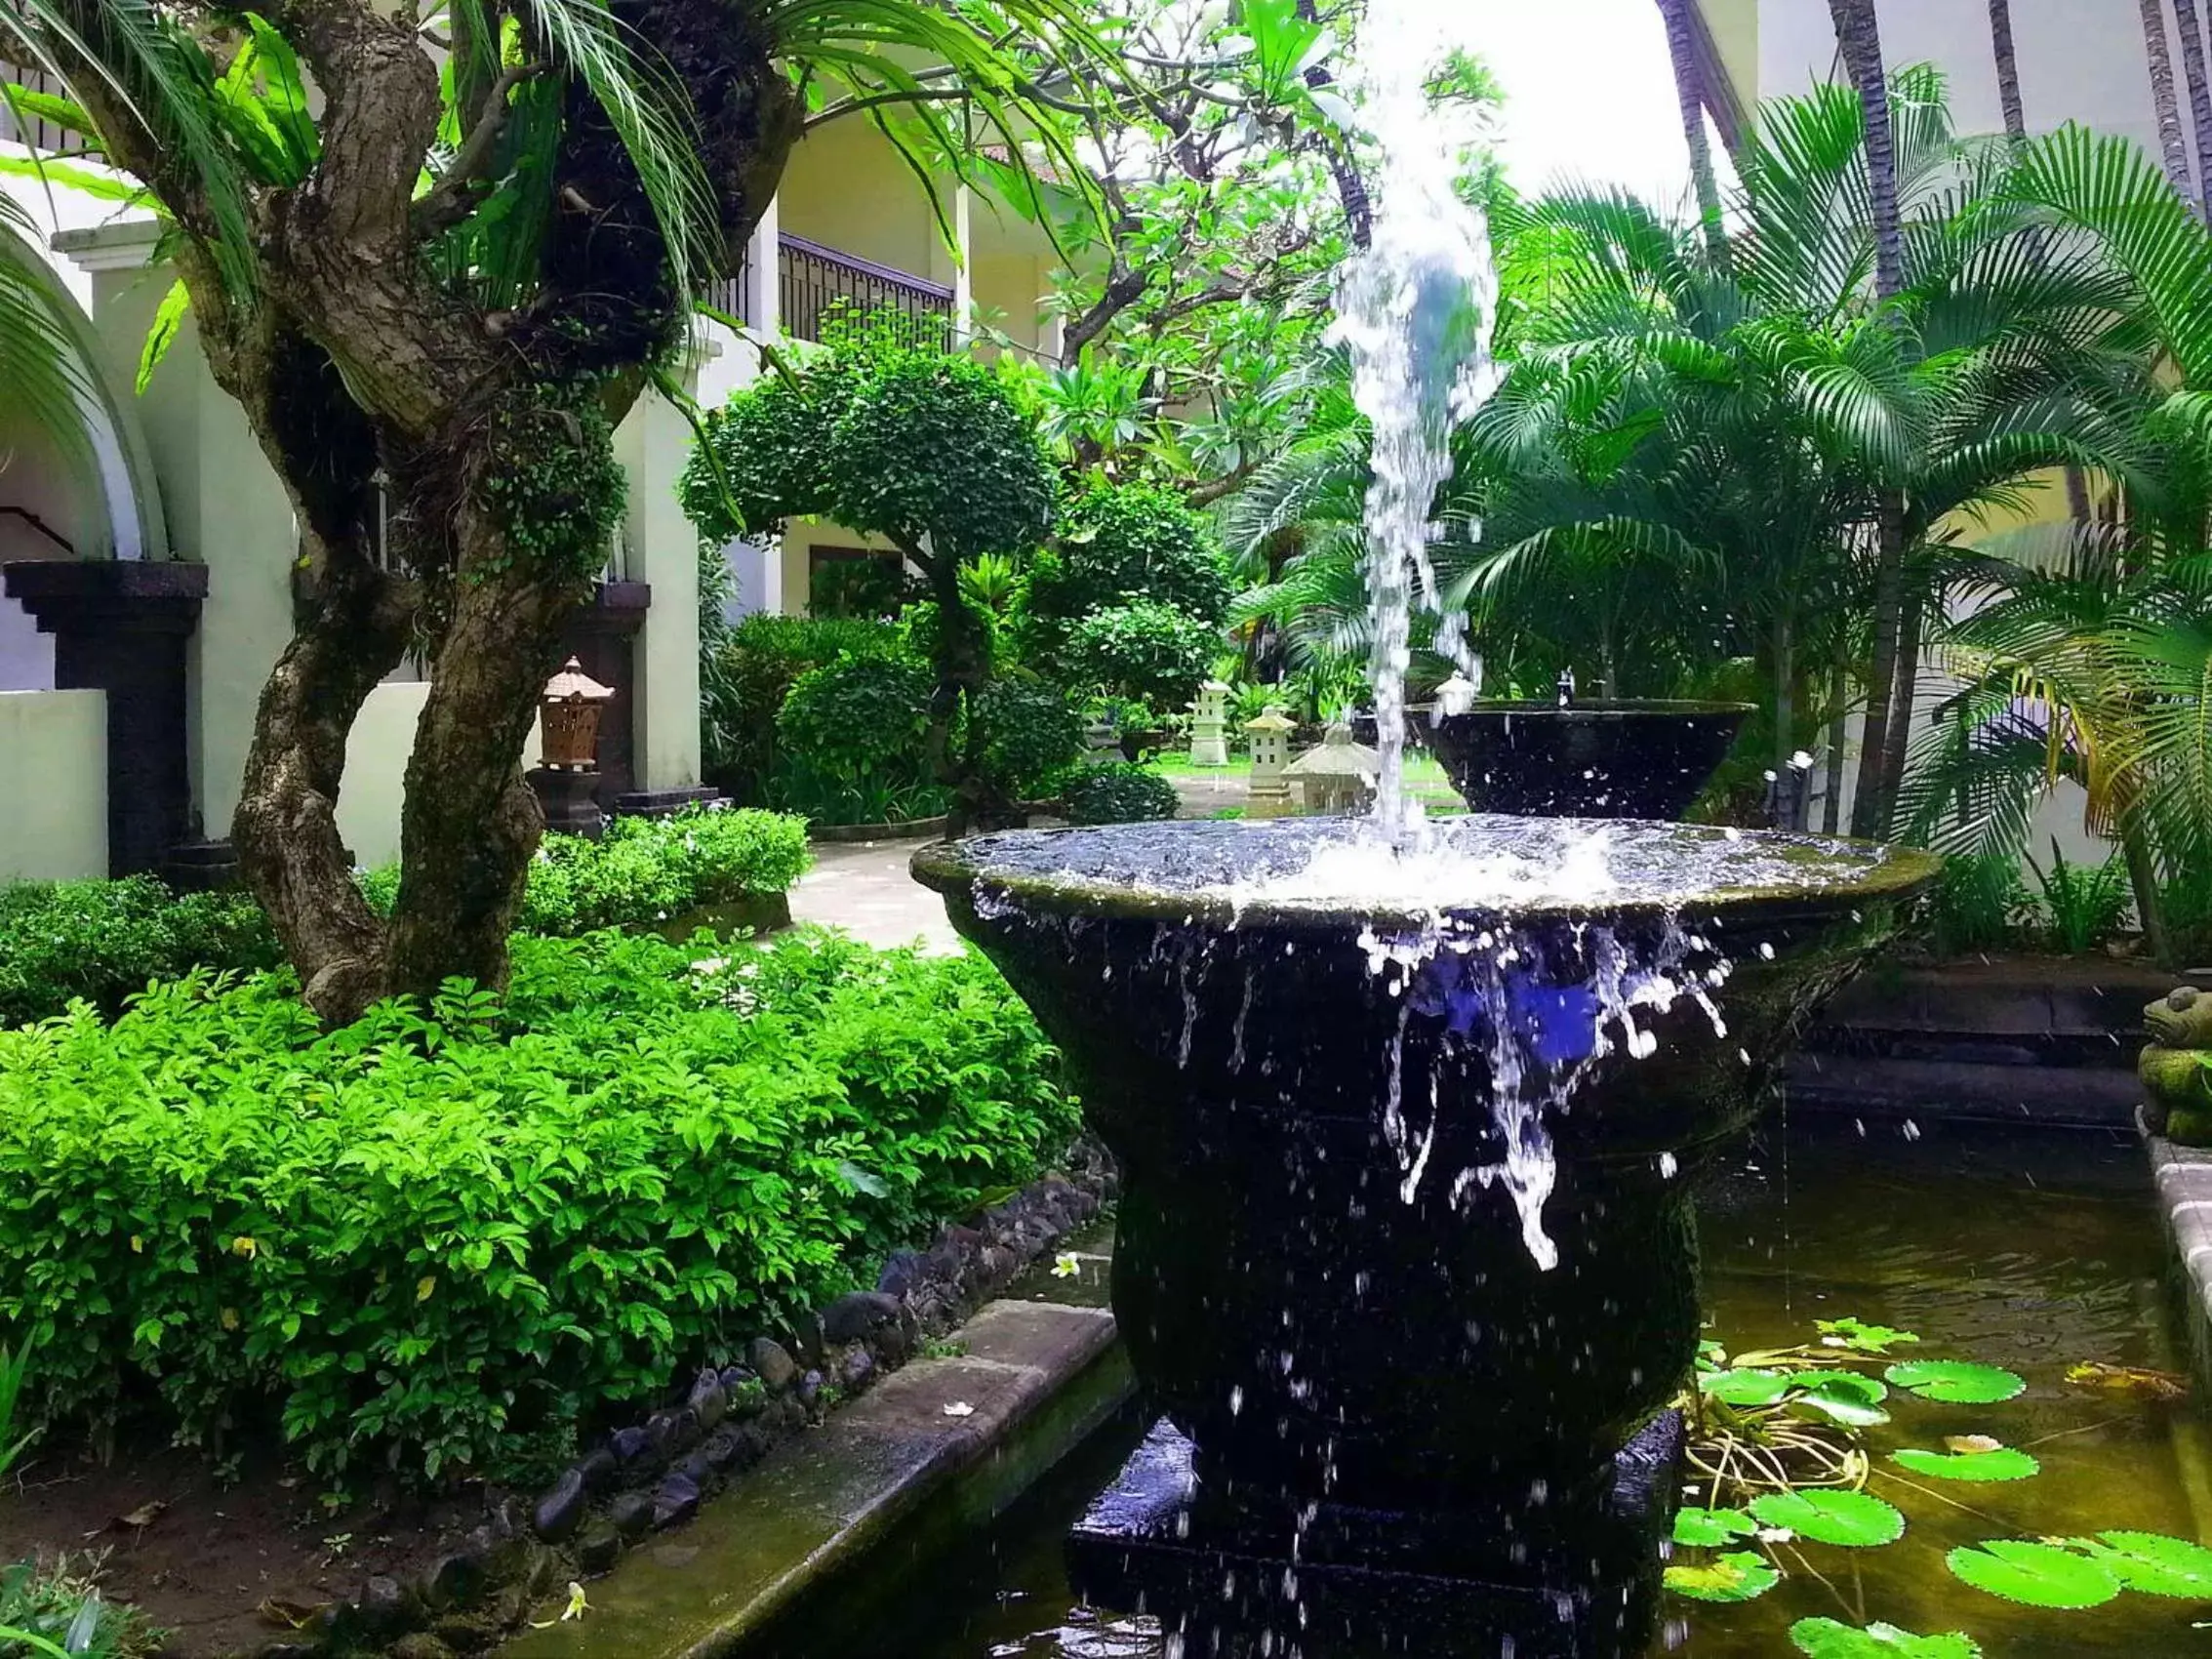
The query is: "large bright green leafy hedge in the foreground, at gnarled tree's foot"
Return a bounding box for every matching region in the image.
[0,934,1075,1482]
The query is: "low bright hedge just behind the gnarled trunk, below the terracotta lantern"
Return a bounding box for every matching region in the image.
[361,807,812,938]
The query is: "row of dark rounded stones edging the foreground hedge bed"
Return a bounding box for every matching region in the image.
[255,1144,1117,1659]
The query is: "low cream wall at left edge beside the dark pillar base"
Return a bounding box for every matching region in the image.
[0,690,108,880]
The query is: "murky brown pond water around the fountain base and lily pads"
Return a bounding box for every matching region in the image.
[787,1114,2212,1659]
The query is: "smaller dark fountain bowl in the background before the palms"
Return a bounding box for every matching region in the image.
[1411,702,1754,819]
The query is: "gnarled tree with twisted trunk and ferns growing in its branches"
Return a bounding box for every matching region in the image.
[0,0,1119,1020]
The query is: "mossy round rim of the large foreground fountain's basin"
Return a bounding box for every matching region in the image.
[909,823,1942,934]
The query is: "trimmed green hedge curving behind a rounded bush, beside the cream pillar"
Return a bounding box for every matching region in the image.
[699,613,905,805]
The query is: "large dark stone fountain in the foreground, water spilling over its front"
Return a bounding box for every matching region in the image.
[913,816,1936,1659]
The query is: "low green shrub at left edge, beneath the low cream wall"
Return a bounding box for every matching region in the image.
[0,876,283,1024]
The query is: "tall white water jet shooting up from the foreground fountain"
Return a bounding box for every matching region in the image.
[1332,0,1498,845]
